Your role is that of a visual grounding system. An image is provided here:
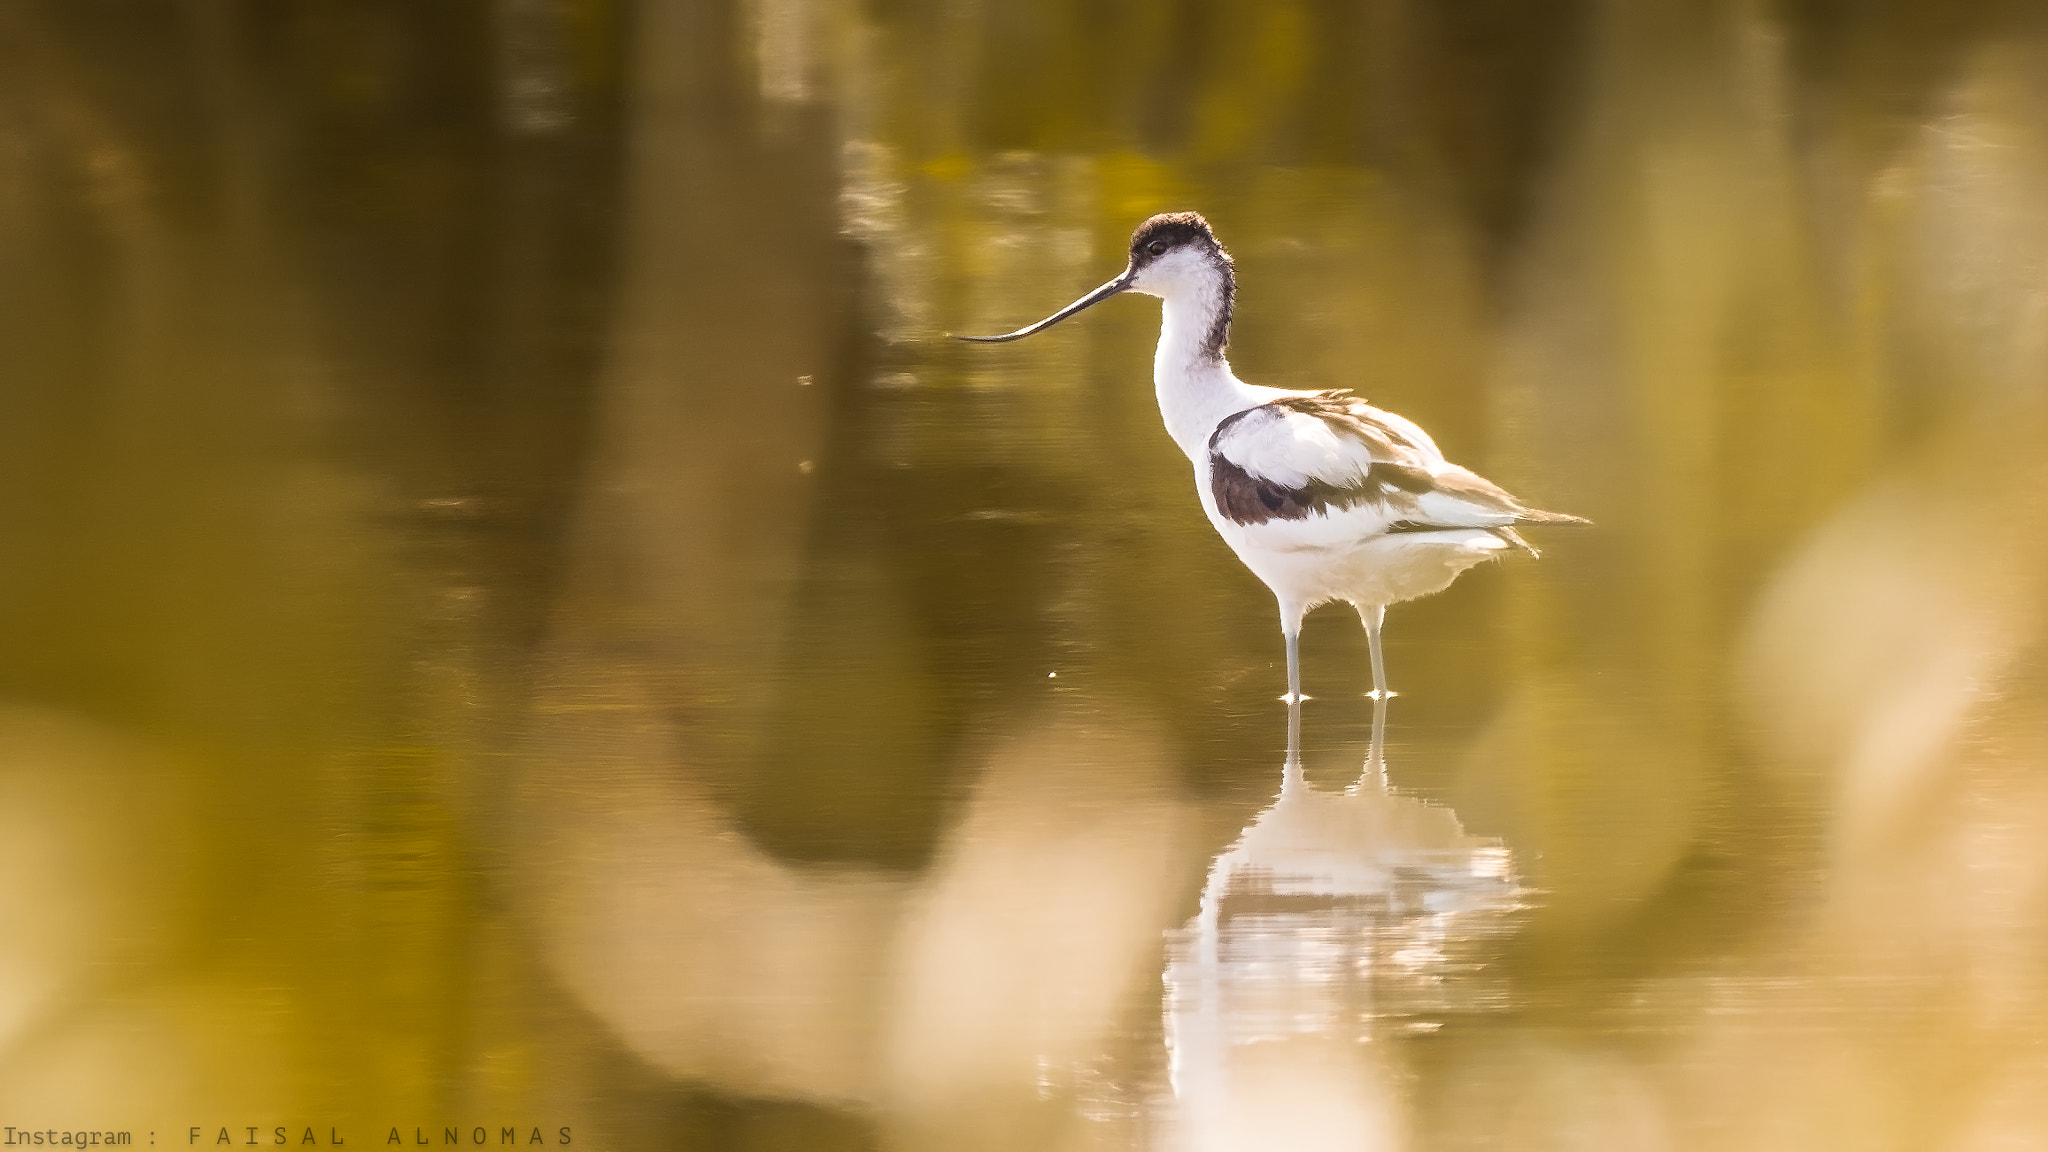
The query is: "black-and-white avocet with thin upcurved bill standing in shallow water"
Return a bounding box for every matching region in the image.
[958,211,1585,703]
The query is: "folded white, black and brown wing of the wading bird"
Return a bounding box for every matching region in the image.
[1208,392,1540,531]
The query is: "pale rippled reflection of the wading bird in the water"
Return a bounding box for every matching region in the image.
[1163,699,1524,1152]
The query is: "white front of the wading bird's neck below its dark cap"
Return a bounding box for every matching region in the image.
[1153,273,1255,463]
